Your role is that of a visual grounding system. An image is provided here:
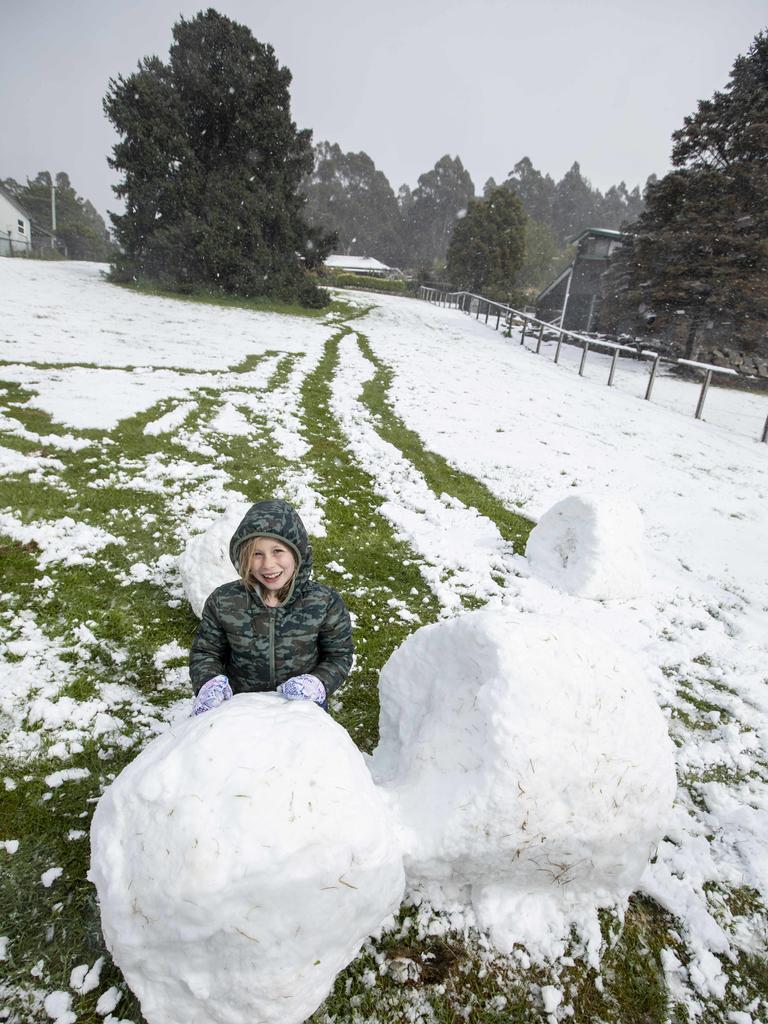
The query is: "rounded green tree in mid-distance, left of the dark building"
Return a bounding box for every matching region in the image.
[446,188,525,300]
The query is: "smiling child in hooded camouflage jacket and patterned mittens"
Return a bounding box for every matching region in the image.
[189,499,353,715]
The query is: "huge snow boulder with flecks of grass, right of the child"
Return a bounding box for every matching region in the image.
[371,609,676,956]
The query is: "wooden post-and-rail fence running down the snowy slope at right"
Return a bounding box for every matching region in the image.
[419,285,768,443]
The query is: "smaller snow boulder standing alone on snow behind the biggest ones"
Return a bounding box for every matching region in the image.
[525,495,648,601]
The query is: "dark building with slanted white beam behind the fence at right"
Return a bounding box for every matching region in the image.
[536,227,622,331]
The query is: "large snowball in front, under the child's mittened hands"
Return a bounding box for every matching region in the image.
[89,693,403,1024]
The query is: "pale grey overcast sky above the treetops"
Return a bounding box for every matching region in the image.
[0,0,768,223]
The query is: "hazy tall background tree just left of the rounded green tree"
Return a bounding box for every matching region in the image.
[401,155,475,267]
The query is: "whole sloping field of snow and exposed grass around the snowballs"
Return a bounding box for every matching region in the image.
[0,259,768,1024]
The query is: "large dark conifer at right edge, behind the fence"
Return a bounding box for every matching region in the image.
[604,33,768,355]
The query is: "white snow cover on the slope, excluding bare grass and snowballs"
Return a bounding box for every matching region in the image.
[0,260,768,1024]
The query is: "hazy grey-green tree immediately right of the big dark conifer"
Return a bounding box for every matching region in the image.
[302,142,402,264]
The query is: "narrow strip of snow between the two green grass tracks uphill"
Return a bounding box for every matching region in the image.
[331,334,516,614]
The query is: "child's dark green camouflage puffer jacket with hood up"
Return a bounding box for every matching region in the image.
[189,500,353,693]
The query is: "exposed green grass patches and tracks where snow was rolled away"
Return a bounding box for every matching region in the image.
[0,284,768,1024]
